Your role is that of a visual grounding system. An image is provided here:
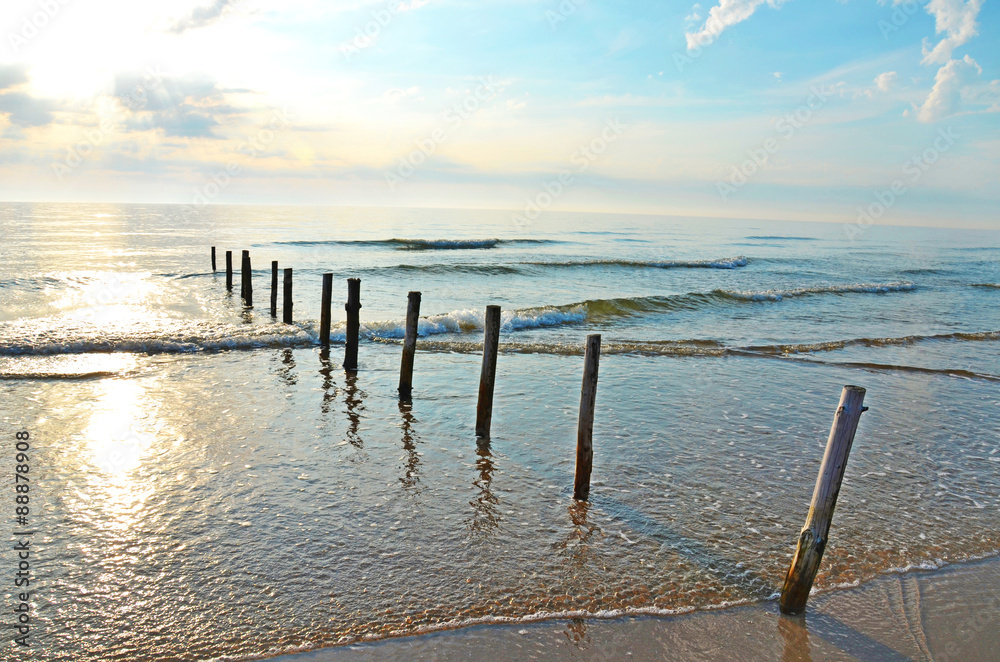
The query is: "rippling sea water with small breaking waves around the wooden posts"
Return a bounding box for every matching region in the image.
[0,203,1000,660]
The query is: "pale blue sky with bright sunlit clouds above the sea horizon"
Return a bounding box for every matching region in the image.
[0,0,1000,229]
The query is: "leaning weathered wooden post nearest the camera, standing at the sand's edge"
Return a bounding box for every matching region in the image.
[780,386,868,615]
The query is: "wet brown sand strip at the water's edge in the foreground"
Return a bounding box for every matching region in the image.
[274,557,1000,662]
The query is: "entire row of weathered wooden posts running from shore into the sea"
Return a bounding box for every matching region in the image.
[212,246,868,615]
